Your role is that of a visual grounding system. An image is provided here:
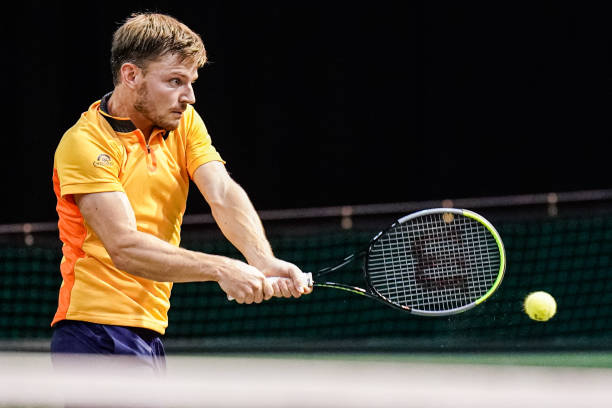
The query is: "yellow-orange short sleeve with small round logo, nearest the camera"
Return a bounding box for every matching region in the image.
[54,131,123,196]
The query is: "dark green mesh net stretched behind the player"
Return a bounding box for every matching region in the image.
[0,190,612,352]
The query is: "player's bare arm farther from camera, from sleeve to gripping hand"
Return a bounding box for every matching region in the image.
[193,161,311,297]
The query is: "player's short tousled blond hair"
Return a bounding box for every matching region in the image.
[111,13,206,85]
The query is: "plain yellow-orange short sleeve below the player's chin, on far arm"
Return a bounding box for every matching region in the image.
[186,108,225,177]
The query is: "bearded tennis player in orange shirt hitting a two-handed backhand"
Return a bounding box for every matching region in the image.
[51,13,310,368]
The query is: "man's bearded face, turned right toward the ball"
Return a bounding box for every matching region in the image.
[134,54,198,130]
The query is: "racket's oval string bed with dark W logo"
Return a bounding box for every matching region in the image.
[367,213,501,312]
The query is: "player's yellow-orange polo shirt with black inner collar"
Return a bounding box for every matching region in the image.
[51,94,223,334]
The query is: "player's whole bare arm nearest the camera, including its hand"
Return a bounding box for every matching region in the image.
[74,192,273,303]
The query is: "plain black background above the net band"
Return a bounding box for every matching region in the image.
[0,1,611,223]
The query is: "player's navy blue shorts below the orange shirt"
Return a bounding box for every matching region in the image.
[51,320,166,373]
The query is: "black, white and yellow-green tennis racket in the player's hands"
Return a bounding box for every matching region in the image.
[232,208,506,316]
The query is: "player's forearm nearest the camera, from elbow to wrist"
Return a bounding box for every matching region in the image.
[109,231,235,282]
